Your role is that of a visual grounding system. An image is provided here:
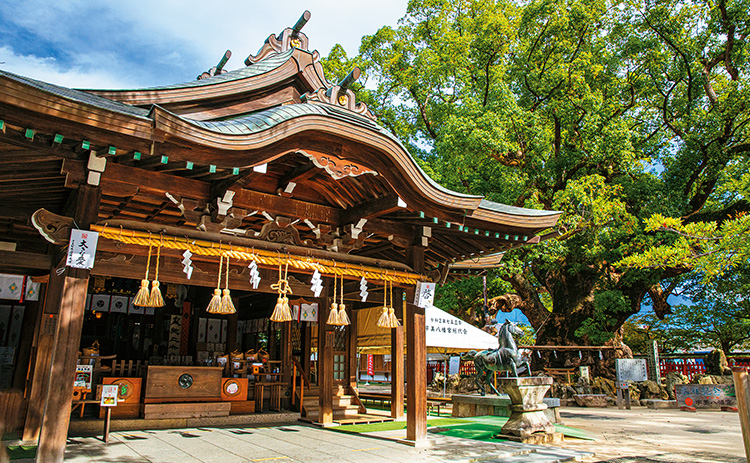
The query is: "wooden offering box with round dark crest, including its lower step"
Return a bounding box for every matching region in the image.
[143,365,230,419]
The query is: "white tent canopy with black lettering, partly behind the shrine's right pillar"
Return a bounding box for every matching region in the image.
[357,306,498,354]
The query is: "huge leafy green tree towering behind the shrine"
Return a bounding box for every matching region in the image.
[328,0,750,345]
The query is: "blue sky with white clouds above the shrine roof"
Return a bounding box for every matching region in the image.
[0,0,406,88]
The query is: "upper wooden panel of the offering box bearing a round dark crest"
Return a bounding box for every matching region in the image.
[144,365,222,403]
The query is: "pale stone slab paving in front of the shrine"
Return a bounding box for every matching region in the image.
[54,423,587,463]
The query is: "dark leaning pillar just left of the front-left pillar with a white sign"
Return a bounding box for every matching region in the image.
[23,280,55,442]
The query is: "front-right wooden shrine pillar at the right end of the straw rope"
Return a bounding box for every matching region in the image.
[404,246,427,442]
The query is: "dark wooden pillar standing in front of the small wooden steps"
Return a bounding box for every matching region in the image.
[318,278,335,424]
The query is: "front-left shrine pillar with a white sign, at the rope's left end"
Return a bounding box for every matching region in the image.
[37,185,101,463]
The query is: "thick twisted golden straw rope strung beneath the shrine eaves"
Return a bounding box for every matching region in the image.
[91,225,423,285]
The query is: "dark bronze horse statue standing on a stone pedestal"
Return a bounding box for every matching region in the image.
[466,320,531,395]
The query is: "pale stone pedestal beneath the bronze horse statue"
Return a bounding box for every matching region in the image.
[497,376,563,444]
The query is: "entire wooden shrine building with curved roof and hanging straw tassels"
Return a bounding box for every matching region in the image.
[0,12,560,462]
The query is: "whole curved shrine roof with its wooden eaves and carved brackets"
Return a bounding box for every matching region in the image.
[0,16,560,280]
